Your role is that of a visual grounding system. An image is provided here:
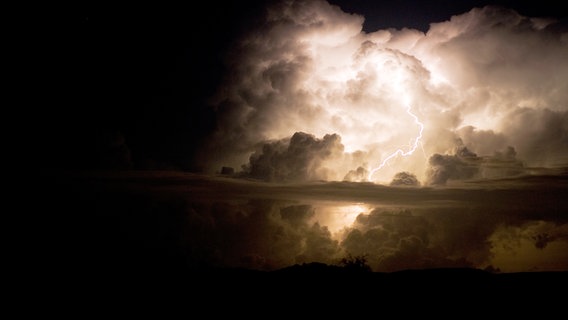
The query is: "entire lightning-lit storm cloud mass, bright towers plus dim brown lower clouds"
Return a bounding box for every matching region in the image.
[169,1,568,272]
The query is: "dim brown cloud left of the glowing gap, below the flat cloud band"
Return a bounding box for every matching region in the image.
[183,200,340,270]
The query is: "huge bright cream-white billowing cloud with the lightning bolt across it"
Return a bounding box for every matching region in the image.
[199,0,568,183]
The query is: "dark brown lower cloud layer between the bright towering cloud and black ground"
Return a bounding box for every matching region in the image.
[50,172,568,272]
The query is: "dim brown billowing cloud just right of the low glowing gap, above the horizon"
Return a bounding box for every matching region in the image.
[342,208,494,272]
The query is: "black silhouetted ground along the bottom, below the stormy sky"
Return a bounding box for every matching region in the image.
[44,261,568,312]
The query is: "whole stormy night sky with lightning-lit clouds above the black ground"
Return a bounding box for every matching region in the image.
[35,0,568,296]
